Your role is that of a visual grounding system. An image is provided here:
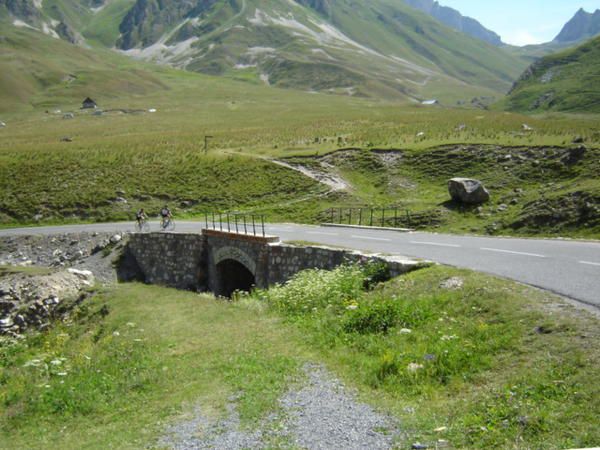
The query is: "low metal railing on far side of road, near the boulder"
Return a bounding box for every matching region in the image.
[324,207,440,228]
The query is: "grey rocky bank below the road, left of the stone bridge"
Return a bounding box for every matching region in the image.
[0,233,123,337]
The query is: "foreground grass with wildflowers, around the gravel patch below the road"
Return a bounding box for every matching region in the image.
[0,267,600,449]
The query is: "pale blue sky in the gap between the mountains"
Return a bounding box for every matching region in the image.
[439,0,600,45]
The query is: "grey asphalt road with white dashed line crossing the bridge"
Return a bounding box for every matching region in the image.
[0,222,600,308]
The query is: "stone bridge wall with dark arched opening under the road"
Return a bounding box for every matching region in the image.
[120,230,421,297]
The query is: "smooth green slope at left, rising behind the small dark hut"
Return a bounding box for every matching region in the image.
[0,22,168,114]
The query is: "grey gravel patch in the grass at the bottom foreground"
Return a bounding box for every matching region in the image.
[160,364,398,450]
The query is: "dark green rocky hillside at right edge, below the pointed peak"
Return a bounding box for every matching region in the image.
[503,38,600,112]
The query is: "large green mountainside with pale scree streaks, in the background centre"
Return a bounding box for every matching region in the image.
[0,0,525,104]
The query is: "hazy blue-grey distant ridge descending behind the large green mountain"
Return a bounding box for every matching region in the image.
[404,0,503,46]
